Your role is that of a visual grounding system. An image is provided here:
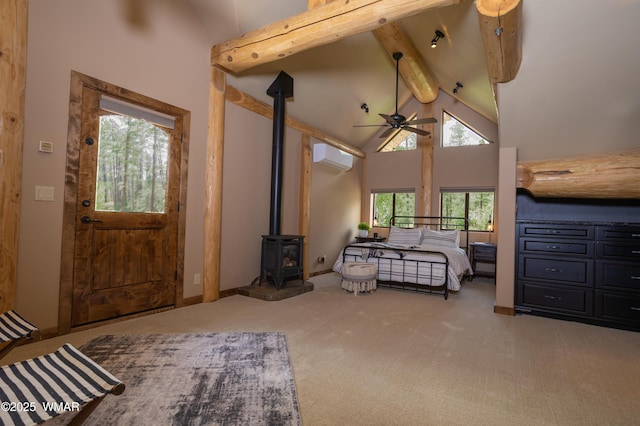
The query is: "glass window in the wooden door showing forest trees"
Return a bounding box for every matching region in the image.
[95,114,169,213]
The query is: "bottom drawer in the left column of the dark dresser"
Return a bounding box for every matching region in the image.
[519,282,593,315]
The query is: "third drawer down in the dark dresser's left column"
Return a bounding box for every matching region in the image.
[518,255,593,286]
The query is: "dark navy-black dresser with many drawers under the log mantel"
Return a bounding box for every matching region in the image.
[515,194,640,331]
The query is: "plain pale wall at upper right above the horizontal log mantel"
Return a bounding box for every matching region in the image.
[497,0,640,161]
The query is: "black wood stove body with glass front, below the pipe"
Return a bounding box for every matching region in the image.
[260,235,304,290]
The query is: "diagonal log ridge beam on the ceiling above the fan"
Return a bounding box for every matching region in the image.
[373,22,440,104]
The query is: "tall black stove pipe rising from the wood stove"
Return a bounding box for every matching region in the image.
[267,71,293,235]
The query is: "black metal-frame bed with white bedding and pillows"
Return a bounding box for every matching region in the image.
[333,216,473,299]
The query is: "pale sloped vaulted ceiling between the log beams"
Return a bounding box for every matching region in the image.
[182,0,497,148]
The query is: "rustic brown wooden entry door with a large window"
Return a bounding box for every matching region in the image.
[71,87,182,327]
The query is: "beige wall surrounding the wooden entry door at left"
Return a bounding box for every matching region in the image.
[16,0,211,329]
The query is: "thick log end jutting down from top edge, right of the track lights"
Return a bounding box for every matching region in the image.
[476,0,522,83]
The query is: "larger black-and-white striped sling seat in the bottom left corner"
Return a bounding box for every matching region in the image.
[0,344,125,425]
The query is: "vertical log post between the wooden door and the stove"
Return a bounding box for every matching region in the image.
[202,68,227,302]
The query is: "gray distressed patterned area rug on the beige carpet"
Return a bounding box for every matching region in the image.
[65,332,302,425]
